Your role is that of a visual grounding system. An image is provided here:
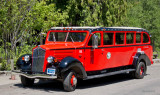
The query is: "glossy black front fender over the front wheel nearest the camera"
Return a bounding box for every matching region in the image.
[58,57,87,79]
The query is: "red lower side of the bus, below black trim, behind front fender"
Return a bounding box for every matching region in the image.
[85,45,152,71]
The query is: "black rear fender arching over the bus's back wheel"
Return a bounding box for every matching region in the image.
[133,52,151,68]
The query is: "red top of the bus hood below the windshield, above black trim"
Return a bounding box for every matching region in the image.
[40,42,84,50]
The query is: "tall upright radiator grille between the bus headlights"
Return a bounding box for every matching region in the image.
[32,47,45,72]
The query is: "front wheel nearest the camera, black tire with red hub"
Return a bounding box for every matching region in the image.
[63,71,77,92]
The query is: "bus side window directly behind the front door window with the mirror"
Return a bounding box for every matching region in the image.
[103,33,113,45]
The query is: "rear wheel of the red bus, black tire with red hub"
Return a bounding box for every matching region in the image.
[130,62,147,79]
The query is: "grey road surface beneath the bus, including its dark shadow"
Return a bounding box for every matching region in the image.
[0,64,160,95]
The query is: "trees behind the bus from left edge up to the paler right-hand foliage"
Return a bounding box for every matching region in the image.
[0,0,127,70]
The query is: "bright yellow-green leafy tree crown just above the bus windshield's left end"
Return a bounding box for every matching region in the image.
[29,0,68,32]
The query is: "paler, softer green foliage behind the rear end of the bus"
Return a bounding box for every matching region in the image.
[123,0,160,50]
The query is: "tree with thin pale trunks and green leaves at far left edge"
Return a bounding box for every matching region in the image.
[0,0,34,67]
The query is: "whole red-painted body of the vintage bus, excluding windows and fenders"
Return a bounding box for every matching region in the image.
[33,30,152,71]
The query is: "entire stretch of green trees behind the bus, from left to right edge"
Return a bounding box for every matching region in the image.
[0,0,160,69]
